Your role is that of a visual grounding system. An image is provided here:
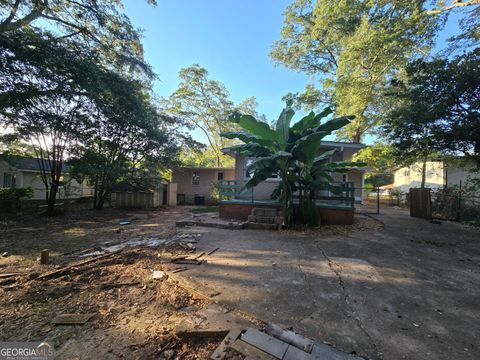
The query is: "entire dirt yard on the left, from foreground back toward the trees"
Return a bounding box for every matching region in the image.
[0,207,229,359]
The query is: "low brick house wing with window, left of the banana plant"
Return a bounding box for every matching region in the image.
[172,168,235,205]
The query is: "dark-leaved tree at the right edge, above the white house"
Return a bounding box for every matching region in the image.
[384,53,480,187]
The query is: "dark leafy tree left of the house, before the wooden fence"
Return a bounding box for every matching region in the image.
[70,68,182,210]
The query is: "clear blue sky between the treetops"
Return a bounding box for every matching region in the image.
[124,0,464,143]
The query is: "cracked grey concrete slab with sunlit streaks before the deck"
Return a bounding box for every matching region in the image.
[168,209,480,360]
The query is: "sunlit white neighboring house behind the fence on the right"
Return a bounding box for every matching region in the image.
[393,159,480,192]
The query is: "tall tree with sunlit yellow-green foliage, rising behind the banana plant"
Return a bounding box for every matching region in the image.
[270,0,441,142]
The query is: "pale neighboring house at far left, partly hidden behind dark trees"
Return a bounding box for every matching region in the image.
[0,157,93,200]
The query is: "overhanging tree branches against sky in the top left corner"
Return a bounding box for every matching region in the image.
[0,0,156,78]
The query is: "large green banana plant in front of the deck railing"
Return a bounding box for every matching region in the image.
[221,102,361,228]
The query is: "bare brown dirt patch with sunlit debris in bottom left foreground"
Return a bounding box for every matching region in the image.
[0,247,222,359]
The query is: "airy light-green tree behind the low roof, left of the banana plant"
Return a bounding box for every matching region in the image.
[161,64,256,166]
